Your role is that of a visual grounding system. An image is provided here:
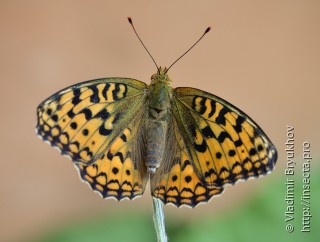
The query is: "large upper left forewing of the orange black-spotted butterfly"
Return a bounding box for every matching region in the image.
[37,78,146,164]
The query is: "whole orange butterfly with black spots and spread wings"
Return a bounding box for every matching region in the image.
[36,18,277,207]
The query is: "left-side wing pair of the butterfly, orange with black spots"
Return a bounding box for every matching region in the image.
[37,78,147,200]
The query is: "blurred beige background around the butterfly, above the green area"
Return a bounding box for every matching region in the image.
[0,0,320,241]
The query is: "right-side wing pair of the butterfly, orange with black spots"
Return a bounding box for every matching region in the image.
[152,87,277,207]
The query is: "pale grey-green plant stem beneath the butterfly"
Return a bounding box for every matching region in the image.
[152,197,168,242]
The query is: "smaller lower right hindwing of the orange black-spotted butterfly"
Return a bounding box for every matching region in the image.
[151,124,223,207]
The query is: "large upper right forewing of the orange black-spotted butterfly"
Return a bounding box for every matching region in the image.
[172,87,277,188]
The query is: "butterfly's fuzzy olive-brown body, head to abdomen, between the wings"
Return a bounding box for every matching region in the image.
[145,68,172,173]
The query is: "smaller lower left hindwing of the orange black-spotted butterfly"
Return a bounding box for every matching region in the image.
[75,112,148,200]
